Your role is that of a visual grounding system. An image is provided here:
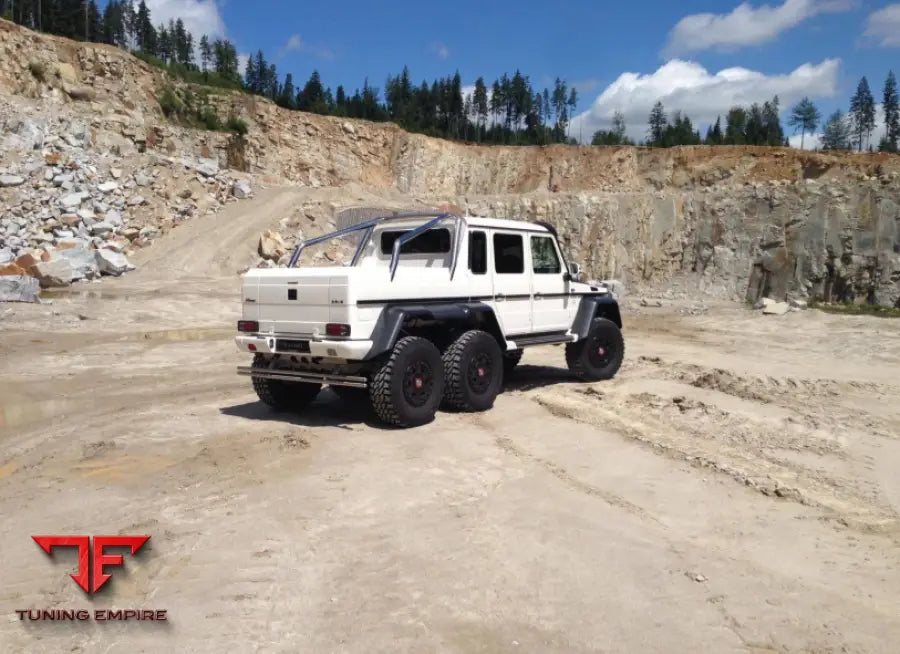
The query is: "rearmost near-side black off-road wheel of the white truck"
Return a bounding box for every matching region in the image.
[369,336,444,427]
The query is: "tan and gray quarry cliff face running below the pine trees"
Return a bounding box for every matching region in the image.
[0,21,900,305]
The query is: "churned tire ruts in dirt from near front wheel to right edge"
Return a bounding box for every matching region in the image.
[531,380,898,532]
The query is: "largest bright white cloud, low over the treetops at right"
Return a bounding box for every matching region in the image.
[571,59,840,140]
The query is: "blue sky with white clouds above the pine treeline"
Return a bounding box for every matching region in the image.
[147,0,900,147]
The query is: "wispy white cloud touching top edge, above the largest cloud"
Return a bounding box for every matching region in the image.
[663,0,856,57]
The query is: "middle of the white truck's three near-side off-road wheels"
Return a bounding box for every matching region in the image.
[443,329,504,411]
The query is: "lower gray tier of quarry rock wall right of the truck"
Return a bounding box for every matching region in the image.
[456,180,900,306]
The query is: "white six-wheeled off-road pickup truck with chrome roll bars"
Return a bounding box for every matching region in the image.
[235,212,625,427]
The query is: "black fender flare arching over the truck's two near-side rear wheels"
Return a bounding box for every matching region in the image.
[363,302,506,361]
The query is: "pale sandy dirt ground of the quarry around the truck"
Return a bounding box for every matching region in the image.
[0,191,900,653]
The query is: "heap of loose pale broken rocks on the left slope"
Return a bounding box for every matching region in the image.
[0,106,253,301]
